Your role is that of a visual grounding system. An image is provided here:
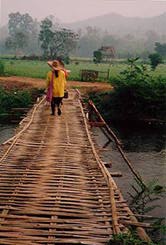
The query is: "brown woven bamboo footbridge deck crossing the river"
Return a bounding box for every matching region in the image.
[0,90,148,245]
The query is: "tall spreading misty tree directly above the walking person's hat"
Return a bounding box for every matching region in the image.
[39,18,78,59]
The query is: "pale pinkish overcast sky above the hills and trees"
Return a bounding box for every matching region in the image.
[0,0,166,25]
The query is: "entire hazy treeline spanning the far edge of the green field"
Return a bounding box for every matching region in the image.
[0,12,166,59]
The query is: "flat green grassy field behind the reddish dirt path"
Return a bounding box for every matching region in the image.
[3,60,166,81]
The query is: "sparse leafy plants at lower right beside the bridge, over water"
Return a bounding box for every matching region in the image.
[129,179,166,242]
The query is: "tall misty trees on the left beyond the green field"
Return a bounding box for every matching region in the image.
[0,12,78,59]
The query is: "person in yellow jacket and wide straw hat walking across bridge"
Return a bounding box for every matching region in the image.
[46,60,66,116]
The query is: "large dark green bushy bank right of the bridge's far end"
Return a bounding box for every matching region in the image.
[90,58,166,120]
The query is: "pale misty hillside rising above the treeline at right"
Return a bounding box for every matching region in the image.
[67,13,166,35]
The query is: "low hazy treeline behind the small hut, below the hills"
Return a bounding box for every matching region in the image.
[76,27,166,59]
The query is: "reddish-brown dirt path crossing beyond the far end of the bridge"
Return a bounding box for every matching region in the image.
[0,76,112,93]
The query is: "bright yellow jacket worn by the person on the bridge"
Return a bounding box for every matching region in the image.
[47,70,66,97]
